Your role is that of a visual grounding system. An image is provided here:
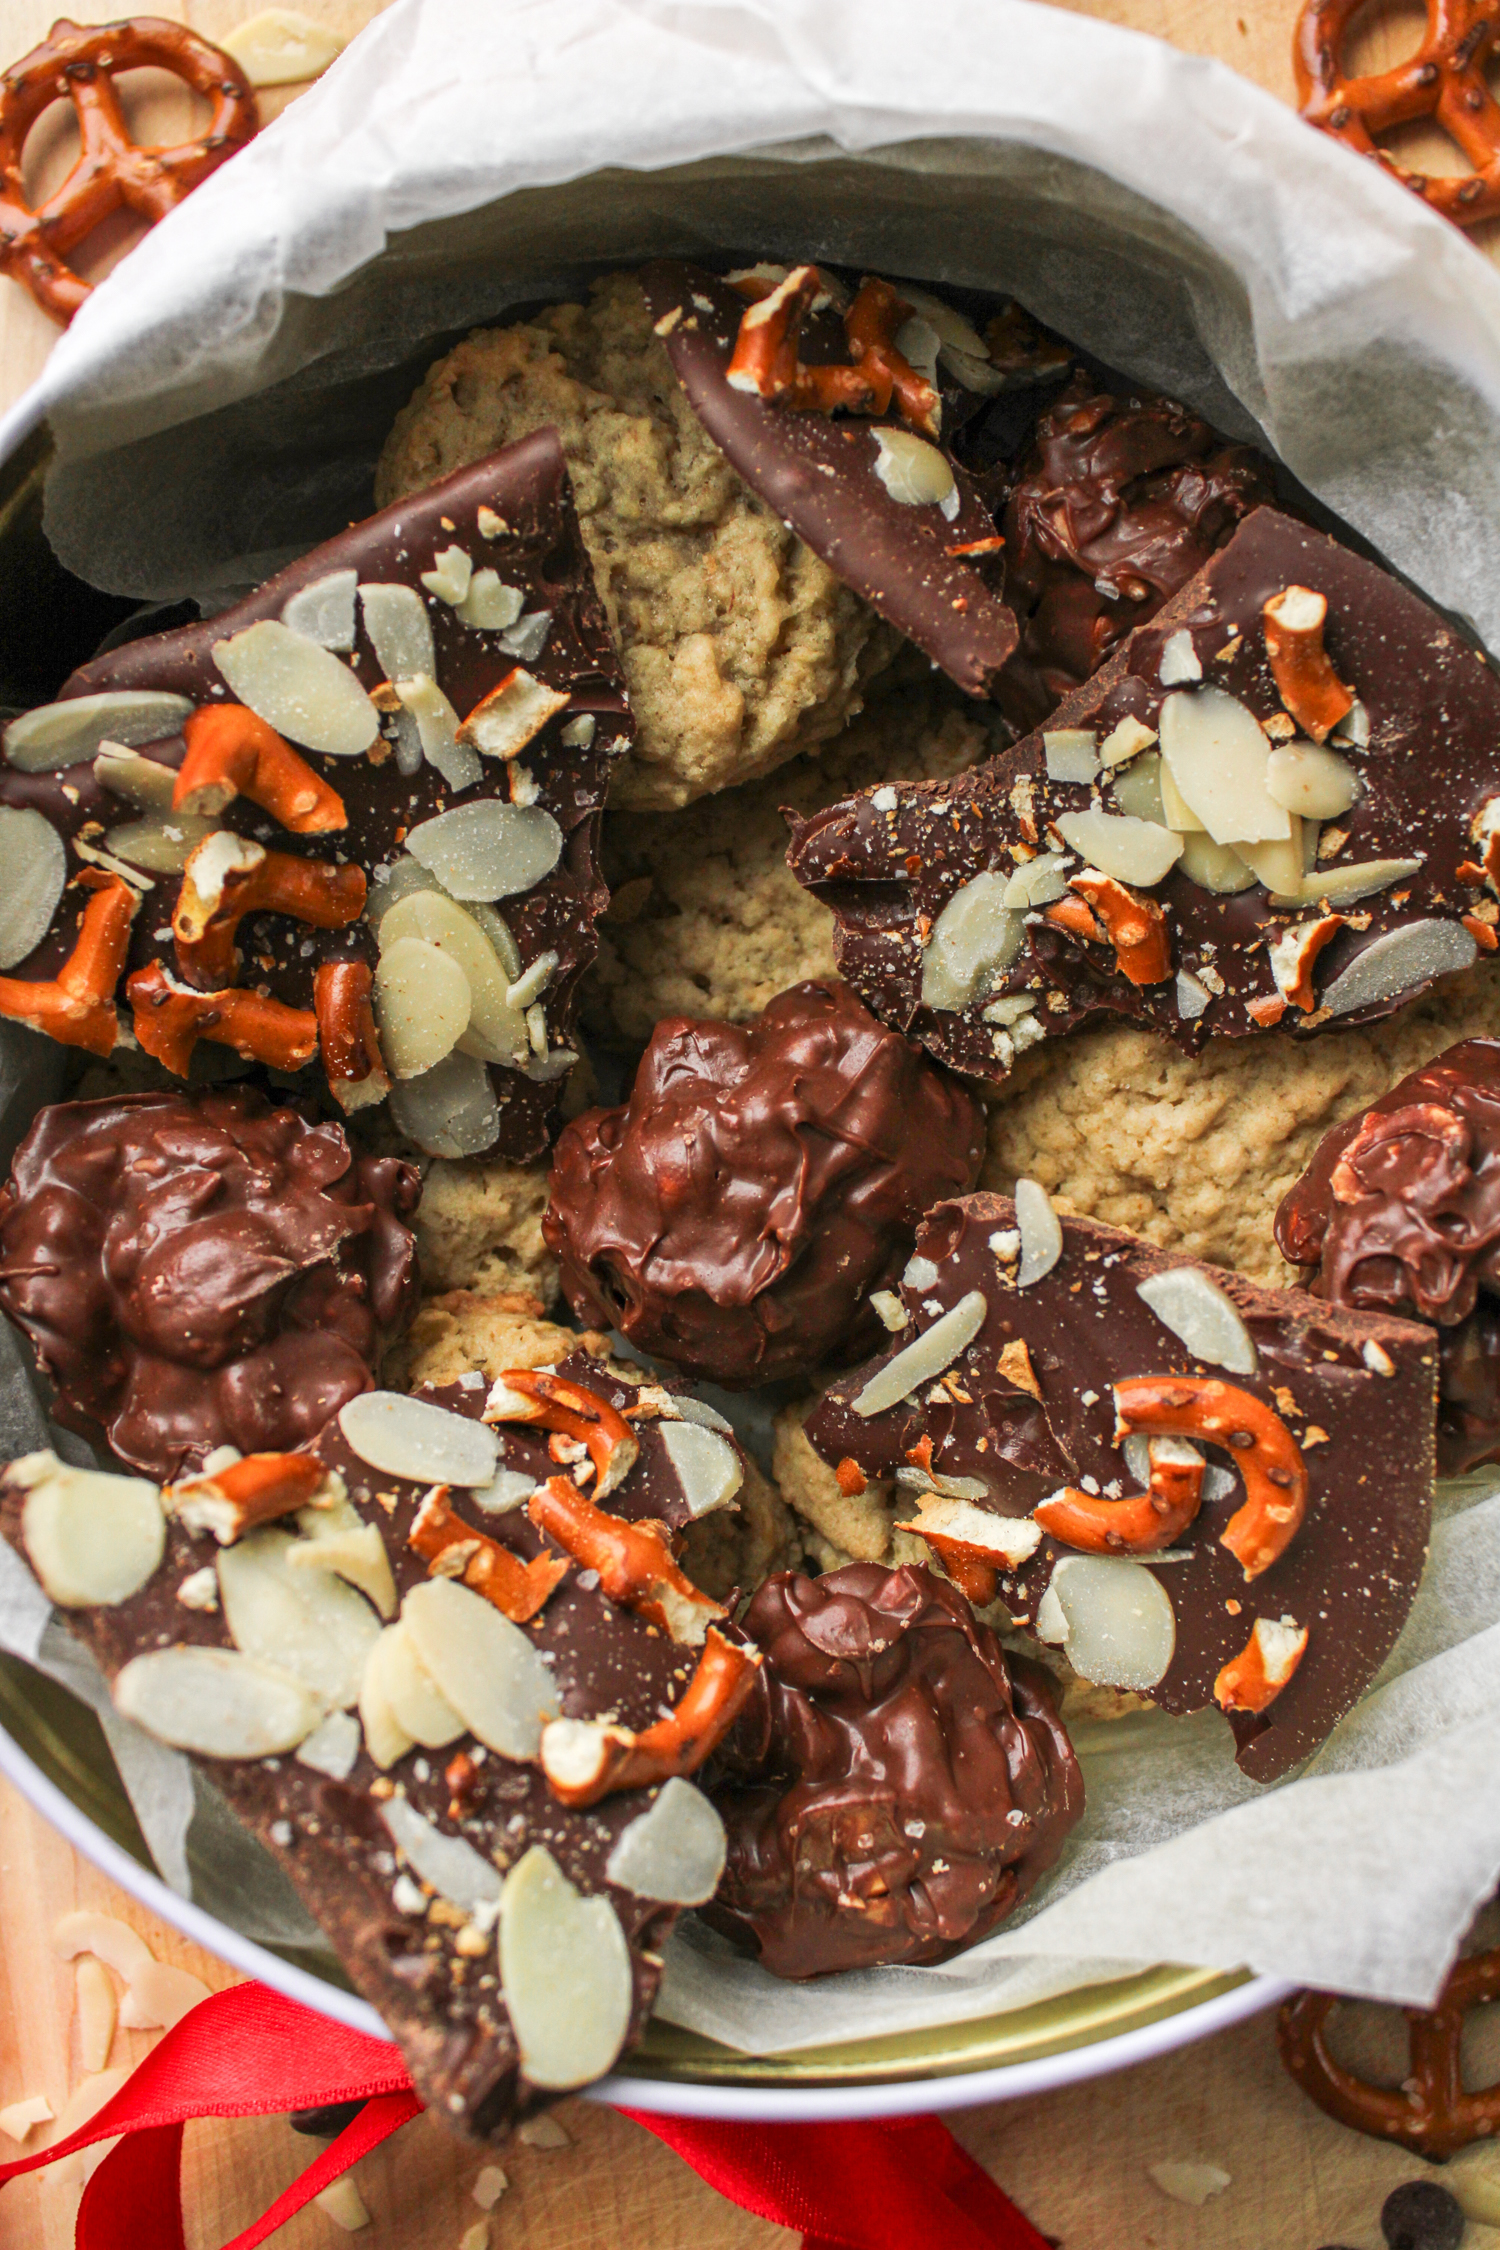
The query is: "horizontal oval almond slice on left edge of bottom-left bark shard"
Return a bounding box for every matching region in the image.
[112,1638,326,1757]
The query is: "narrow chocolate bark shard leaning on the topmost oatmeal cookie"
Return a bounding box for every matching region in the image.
[641,259,1016,695]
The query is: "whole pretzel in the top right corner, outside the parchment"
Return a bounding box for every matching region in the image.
[1293,0,1500,227]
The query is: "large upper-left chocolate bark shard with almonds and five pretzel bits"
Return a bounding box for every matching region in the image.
[0,430,630,1159]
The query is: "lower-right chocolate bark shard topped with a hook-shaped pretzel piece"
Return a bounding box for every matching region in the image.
[807,1181,1437,1782]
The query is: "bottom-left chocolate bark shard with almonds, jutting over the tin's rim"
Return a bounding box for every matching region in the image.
[0,1355,760,2140]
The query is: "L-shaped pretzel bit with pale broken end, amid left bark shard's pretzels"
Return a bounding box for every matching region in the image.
[171,828,367,992]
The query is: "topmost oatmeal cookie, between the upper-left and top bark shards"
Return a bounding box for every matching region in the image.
[376,275,897,808]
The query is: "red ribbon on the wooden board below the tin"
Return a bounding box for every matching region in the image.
[0,1985,1046,2250]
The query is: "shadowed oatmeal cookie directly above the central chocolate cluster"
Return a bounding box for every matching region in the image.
[585,666,994,1044]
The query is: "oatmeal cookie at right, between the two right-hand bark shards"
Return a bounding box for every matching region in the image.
[981,965,1500,1285]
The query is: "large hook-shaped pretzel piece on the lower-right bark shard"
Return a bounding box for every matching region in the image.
[1106,1375,1307,1577]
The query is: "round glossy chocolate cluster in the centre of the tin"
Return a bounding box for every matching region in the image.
[542,981,985,1388]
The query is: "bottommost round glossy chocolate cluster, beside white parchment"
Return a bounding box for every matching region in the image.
[708,1564,1084,1978]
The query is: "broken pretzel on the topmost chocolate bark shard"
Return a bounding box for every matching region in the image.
[726,266,938,437]
